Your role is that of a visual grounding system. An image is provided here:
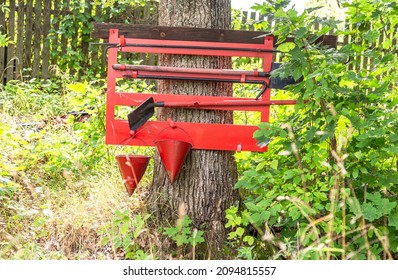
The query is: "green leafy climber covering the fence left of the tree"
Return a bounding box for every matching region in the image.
[47,0,157,80]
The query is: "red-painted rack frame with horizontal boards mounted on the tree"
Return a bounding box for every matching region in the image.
[106,29,280,152]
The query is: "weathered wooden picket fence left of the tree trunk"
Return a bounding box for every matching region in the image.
[0,0,158,83]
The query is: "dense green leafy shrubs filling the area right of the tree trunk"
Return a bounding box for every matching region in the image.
[226,0,398,259]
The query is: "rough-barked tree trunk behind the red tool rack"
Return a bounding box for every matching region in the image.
[148,0,237,258]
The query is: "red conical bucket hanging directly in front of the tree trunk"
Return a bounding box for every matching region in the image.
[155,140,192,183]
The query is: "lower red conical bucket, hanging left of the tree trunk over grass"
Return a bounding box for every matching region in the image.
[116,155,150,196]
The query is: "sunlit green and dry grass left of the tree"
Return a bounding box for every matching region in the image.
[0,77,149,259]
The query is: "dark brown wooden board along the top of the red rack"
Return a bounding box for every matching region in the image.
[91,23,337,47]
